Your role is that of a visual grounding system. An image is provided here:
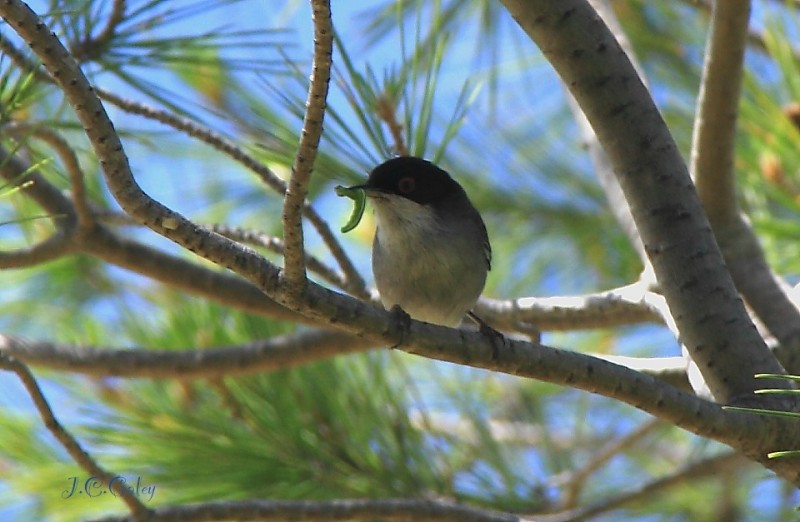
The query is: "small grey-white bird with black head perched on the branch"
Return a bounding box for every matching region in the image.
[351,156,492,327]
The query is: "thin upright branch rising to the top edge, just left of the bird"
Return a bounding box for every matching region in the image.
[282,0,333,304]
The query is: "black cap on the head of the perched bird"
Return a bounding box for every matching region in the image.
[363,156,464,205]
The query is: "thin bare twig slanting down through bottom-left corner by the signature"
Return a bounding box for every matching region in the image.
[0,352,149,520]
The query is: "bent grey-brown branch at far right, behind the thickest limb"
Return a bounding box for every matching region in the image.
[690,0,800,372]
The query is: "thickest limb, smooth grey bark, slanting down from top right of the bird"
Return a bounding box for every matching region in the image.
[503,0,786,403]
